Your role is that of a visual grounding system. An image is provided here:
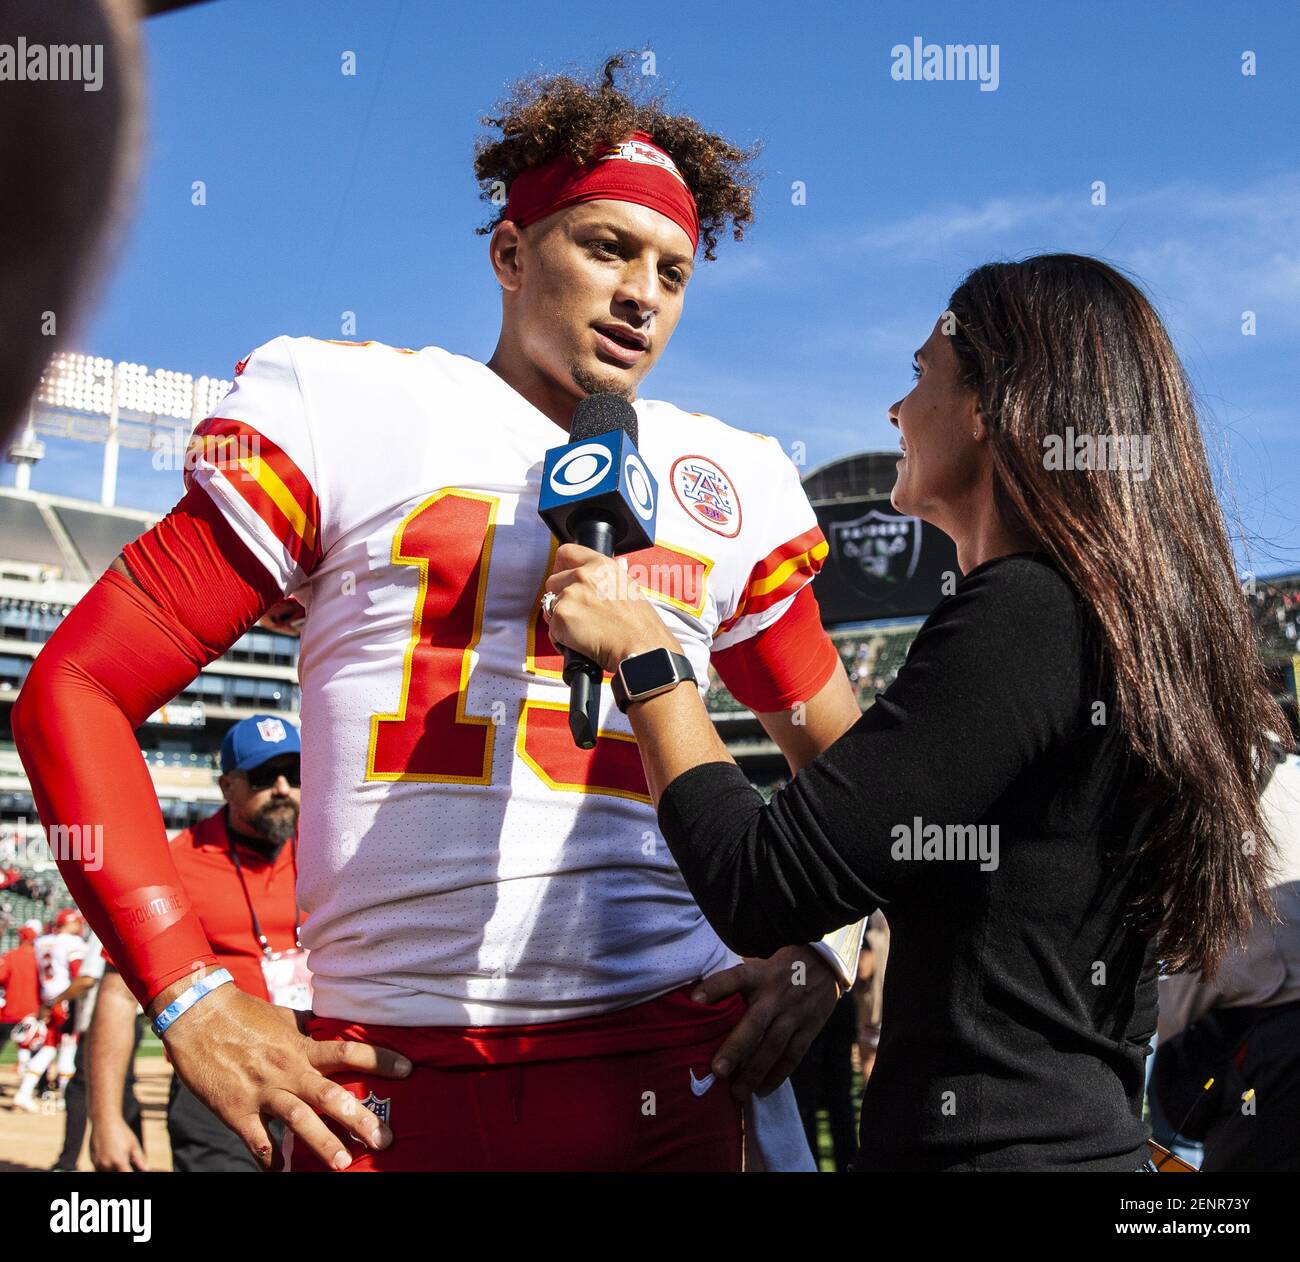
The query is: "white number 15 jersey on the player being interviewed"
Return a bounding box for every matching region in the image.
[186,338,827,1025]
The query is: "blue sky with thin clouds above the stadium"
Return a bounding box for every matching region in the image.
[17,0,1300,573]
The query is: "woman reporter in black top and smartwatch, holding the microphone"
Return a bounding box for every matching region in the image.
[547,255,1284,1170]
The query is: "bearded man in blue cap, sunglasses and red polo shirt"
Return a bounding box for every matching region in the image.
[90,715,311,1172]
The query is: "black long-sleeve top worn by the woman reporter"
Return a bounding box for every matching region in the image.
[659,554,1156,1170]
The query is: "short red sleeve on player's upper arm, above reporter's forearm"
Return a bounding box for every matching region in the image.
[712,582,840,714]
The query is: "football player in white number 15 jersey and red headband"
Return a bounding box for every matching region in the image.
[14,58,861,1170]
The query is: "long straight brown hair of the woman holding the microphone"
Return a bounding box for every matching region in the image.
[949,255,1288,976]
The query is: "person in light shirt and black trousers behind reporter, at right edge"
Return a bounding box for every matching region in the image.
[1151,733,1300,1172]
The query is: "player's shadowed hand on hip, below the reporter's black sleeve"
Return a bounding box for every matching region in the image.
[692,946,840,1102]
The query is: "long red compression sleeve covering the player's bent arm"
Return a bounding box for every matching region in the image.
[12,486,281,1005]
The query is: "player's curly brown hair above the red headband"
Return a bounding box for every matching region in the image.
[475,52,762,259]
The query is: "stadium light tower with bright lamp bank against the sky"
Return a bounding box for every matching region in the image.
[8,352,230,506]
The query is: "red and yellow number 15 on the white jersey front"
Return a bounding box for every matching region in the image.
[365,487,712,802]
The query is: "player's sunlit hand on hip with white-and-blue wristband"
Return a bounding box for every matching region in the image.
[150,985,411,1170]
